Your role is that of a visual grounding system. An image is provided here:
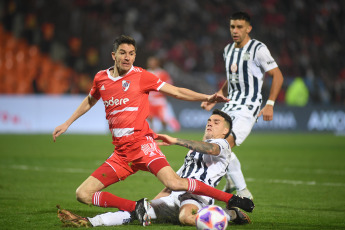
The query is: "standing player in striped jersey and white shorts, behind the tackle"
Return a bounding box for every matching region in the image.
[201,12,284,199]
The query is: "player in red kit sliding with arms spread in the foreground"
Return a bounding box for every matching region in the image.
[53,35,254,226]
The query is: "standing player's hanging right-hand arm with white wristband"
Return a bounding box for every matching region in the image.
[258,67,284,121]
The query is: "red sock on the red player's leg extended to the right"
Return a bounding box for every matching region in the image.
[187,178,233,203]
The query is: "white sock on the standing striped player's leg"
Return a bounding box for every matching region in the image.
[226,152,247,191]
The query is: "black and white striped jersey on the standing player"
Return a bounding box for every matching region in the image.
[223,39,278,115]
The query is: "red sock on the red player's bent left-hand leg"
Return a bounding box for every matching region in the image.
[92,192,136,212]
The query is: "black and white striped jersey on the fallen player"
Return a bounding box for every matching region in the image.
[177,139,231,187]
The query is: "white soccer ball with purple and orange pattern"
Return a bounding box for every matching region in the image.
[195,205,228,230]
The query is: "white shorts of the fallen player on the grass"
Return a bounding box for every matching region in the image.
[151,191,214,224]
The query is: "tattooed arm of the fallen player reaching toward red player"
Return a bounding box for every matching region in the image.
[156,134,220,156]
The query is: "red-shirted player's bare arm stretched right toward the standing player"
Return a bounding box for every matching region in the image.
[160,83,229,103]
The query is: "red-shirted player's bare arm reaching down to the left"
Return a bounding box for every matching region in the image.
[53,96,97,142]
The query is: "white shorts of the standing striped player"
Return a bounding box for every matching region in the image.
[224,106,257,146]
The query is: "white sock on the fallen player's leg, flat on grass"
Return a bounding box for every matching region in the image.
[88,211,131,227]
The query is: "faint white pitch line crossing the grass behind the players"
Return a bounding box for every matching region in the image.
[7,165,345,187]
